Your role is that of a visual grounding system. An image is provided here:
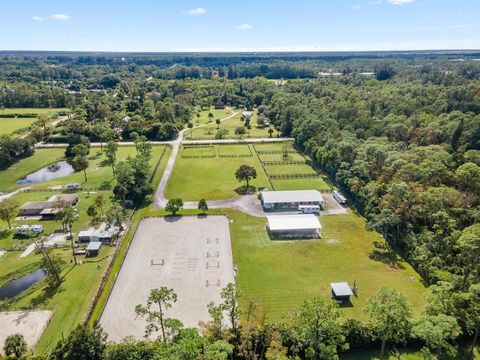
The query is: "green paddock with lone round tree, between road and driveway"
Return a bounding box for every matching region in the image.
[165,148,269,201]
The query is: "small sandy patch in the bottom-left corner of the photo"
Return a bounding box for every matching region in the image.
[0,310,52,354]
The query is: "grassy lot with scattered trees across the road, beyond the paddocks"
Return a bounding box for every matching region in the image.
[184,110,277,140]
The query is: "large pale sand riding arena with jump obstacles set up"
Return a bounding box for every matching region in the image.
[100,216,234,341]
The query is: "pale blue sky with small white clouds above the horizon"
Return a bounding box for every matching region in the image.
[0,0,480,51]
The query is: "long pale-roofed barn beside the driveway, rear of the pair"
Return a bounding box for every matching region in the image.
[260,190,325,210]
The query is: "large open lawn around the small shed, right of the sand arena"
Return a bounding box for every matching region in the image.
[231,212,425,320]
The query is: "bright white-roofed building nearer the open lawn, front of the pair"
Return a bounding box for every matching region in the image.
[267,214,322,238]
